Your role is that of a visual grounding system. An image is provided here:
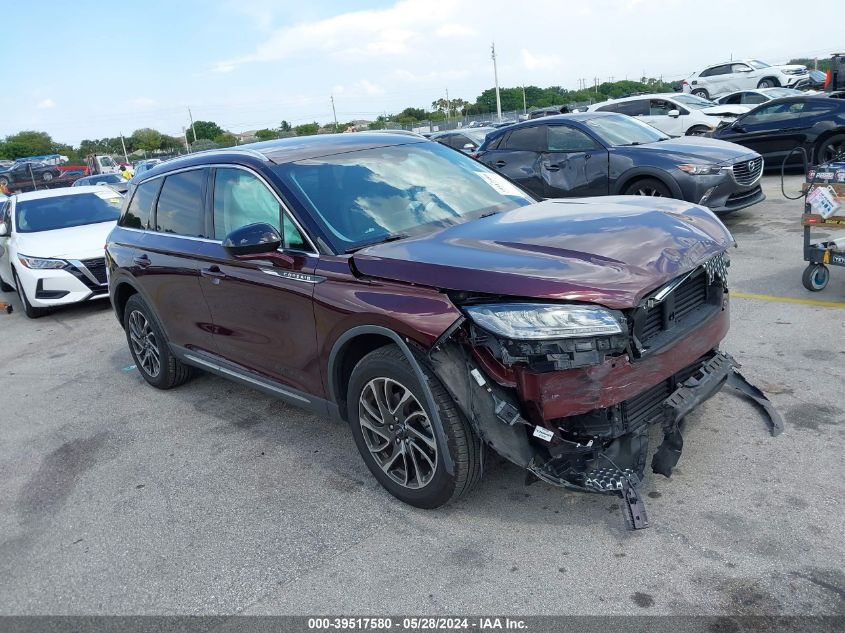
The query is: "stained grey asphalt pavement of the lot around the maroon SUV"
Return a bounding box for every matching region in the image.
[0,176,845,615]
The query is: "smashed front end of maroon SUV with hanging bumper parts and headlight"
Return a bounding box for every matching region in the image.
[428,253,783,528]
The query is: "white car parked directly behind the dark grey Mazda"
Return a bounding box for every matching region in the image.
[587,93,748,136]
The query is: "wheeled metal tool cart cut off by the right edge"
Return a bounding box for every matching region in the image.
[801,170,845,292]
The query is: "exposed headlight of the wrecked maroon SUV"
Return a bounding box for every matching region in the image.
[465,303,622,340]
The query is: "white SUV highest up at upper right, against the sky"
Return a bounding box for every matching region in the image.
[681,59,810,99]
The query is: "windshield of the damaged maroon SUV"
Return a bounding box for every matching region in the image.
[275,142,534,252]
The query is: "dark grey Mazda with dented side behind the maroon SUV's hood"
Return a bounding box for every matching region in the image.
[476,112,765,212]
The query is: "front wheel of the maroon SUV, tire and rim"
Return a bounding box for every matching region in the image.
[347,345,482,508]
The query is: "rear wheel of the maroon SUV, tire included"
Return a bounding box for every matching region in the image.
[123,294,194,389]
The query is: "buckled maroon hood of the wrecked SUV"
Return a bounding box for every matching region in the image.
[352,196,733,309]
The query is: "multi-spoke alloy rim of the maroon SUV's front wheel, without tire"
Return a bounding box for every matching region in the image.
[358,378,437,489]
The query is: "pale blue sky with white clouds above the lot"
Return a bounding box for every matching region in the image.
[0,0,845,144]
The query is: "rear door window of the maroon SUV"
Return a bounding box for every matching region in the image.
[155,169,208,237]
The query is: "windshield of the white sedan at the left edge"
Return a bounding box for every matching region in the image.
[15,190,123,233]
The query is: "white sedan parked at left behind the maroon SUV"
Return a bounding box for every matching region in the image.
[0,187,123,318]
